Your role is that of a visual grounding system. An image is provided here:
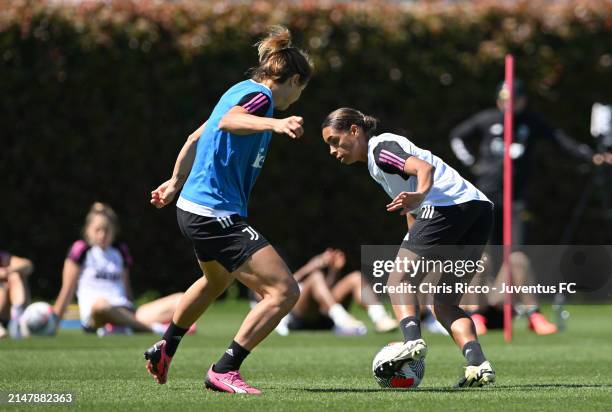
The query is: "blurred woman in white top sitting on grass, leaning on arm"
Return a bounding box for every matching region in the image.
[54,202,190,336]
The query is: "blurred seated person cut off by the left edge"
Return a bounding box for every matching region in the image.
[0,250,34,339]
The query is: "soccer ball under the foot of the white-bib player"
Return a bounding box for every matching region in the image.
[372,342,425,389]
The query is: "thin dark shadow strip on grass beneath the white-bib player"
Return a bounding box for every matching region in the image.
[298,383,612,393]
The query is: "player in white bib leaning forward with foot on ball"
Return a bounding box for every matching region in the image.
[321,108,495,387]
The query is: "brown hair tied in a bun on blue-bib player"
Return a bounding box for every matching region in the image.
[249,26,314,85]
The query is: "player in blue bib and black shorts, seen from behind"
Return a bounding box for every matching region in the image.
[145,27,312,394]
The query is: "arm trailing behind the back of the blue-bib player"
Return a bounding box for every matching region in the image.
[151,122,206,209]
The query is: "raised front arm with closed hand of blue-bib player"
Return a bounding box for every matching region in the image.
[219,106,304,139]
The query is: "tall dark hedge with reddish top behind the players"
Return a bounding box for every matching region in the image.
[0,0,612,296]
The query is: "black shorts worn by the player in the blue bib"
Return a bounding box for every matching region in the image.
[176,208,270,273]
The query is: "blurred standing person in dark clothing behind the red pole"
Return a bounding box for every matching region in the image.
[450,80,610,245]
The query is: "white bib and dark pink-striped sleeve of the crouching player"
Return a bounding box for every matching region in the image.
[368,133,489,211]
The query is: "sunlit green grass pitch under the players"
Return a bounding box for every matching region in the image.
[0,302,612,412]
